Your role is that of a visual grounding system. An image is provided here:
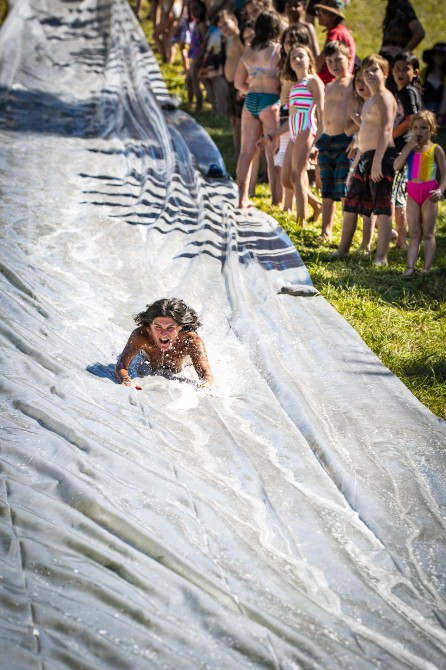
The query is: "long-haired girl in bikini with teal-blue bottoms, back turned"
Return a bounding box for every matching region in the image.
[234,11,281,209]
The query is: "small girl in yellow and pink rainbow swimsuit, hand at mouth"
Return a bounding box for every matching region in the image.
[394,110,446,277]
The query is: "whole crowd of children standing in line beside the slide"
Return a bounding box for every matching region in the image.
[134,0,446,277]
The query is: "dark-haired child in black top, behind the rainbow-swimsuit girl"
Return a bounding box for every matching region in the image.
[392,51,423,249]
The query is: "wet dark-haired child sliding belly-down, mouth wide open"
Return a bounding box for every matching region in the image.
[115,298,213,386]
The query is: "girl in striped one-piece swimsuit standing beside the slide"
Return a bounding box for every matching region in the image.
[258,45,324,227]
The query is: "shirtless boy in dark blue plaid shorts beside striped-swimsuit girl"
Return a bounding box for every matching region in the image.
[316,41,353,241]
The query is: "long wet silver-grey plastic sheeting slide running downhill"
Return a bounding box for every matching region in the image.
[0,0,446,670]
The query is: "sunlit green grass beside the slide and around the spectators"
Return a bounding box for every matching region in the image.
[134,0,446,419]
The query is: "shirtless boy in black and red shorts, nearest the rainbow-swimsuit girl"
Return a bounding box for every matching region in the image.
[332,54,397,265]
